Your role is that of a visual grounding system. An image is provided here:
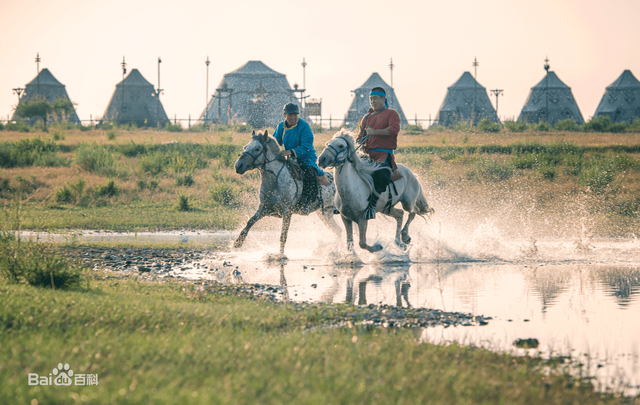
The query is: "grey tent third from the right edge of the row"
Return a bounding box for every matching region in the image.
[436,72,498,126]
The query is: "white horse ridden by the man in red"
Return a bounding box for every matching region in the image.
[318,130,433,252]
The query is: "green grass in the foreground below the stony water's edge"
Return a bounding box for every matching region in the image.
[0,274,625,404]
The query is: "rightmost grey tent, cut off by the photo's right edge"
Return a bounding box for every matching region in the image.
[594,70,640,122]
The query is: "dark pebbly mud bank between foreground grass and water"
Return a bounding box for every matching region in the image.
[63,246,492,328]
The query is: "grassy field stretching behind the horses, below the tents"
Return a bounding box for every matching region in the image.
[0,124,640,237]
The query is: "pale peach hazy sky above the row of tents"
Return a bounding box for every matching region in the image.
[0,0,640,125]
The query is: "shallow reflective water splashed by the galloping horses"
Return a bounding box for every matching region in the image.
[25,218,640,395]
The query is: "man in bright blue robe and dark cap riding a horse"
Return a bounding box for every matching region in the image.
[273,103,329,213]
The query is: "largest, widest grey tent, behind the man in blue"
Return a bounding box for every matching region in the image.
[200,60,299,128]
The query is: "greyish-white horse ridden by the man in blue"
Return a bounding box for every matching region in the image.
[233,131,340,256]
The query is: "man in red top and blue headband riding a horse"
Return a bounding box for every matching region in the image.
[357,87,400,219]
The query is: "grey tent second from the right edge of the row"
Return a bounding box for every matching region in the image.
[518,72,584,125]
